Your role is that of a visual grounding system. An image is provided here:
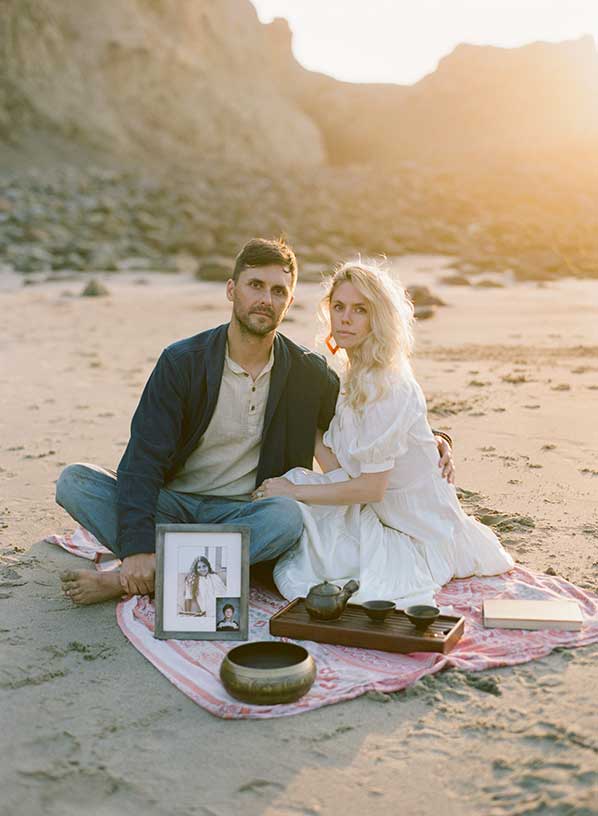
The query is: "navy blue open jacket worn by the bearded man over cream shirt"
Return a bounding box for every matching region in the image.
[117,324,339,558]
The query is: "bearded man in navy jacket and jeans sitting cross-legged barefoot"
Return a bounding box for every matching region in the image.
[56,239,452,604]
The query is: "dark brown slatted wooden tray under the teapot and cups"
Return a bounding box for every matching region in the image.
[270,598,465,654]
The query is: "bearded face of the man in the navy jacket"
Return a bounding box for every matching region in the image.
[226,266,293,337]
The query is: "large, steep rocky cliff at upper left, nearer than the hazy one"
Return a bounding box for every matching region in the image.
[0,0,324,166]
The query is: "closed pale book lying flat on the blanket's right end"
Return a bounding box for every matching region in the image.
[484,598,583,632]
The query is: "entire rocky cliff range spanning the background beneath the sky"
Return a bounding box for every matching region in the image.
[0,0,598,167]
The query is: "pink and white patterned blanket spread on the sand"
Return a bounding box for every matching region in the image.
[47,529,598,719]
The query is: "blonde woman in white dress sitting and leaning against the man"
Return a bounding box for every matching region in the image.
[254,263,513,607]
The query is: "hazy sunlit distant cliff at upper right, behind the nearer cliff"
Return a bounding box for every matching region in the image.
[270,20,598,164]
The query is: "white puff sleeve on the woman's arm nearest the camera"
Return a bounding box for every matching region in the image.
[349,380,425,473]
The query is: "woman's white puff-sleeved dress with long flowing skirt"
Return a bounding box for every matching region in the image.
[274,372,514,608]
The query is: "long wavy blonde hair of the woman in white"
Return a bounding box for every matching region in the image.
[319,260,414,410]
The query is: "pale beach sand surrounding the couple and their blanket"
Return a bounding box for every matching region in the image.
[0,256,598,816]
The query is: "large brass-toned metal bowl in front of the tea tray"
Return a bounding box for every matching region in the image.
[220,641,316,705]
